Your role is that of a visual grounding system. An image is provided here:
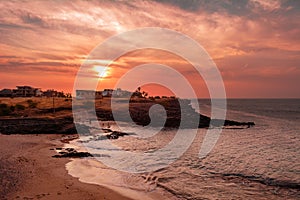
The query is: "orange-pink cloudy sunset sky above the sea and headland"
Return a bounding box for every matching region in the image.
[0,0,300,98]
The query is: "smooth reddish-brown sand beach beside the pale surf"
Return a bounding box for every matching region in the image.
[0,135,129,200]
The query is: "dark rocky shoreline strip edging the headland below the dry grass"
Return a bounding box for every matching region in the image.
[0,99,255,134]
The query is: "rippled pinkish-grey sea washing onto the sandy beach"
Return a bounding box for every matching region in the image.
[66,99,300,199]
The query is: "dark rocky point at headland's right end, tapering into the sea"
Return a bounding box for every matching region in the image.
[96,98,255,128]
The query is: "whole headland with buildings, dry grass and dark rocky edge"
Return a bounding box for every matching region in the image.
[0,86,254,134]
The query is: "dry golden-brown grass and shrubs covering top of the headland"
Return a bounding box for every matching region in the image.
[0,88,177,118]
